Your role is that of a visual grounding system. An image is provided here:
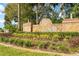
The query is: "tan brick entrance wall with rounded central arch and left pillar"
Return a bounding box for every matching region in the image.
[23,18,79,32]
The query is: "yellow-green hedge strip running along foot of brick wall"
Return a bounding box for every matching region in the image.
[13,32,79,40]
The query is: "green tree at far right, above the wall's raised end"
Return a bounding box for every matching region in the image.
[60,3,79,19]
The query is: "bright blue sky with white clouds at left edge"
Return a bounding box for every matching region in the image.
[0,3,6,28]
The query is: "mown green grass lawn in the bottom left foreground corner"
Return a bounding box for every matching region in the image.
[0,45,58,56]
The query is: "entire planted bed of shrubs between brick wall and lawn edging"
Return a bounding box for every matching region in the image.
[0,32,79,53]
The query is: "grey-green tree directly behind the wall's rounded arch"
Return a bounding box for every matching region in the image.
[32,3,58,24]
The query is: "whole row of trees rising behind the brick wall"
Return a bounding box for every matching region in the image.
[5,3,79,29]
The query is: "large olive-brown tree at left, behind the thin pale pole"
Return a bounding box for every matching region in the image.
[5,4,33,31]
